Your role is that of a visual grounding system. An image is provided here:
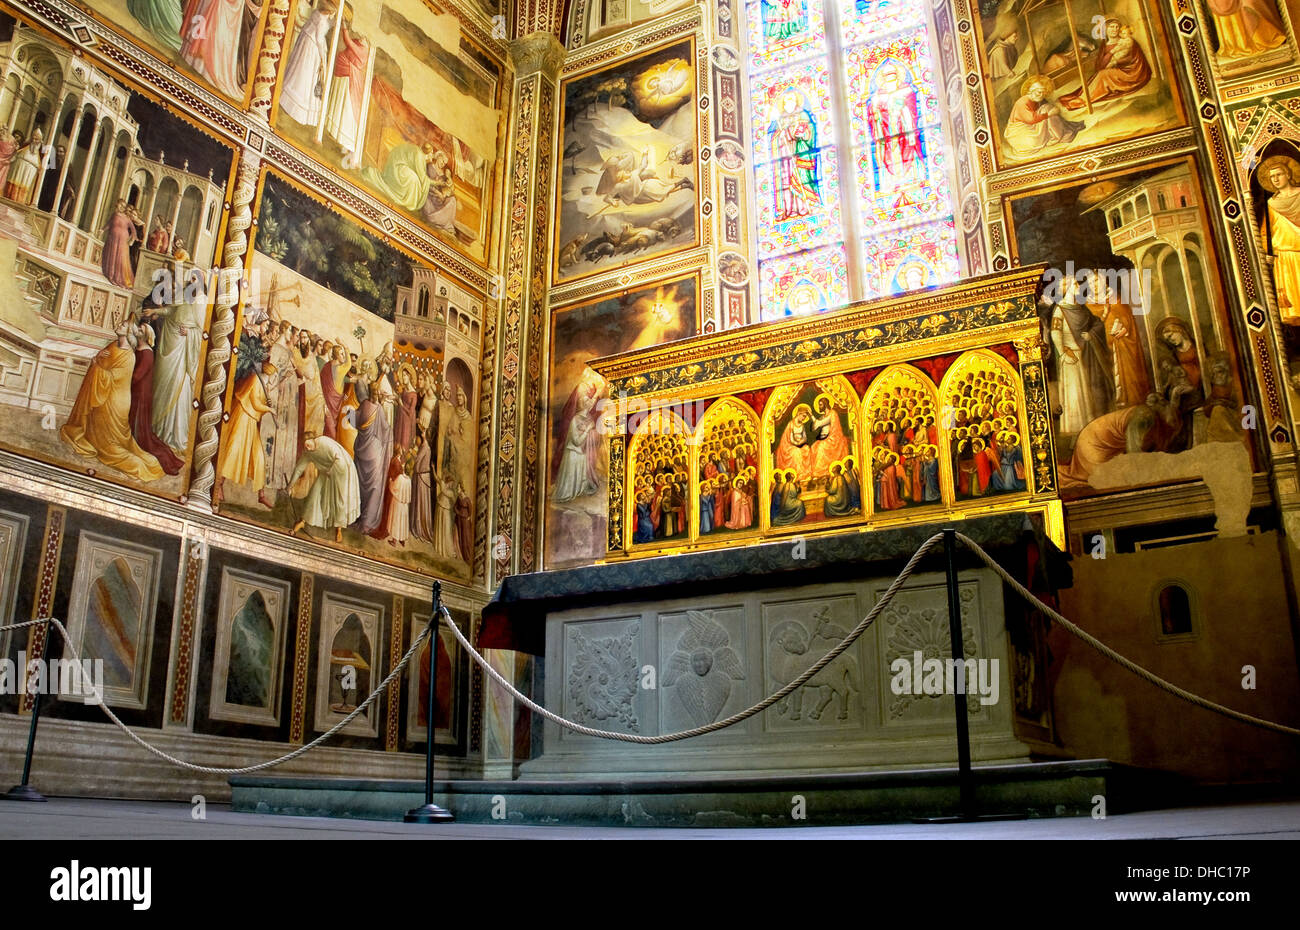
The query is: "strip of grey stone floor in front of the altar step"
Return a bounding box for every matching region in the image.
[0,797,1300,840]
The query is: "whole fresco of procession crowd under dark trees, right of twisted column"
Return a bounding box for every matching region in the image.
[217,174,481,578]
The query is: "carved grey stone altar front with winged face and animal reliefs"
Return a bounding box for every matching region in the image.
[519,568,1030,779]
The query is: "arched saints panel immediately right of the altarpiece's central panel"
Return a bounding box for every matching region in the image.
[863,365,943,514]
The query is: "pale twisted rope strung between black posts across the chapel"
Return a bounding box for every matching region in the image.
[0,522,1300,775]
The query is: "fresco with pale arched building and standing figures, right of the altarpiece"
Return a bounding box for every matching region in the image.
[1009,161,1244,497]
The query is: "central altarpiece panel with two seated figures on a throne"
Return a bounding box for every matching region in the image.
[761,376,863,528]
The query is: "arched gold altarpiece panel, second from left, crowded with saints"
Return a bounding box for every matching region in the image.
[696,398,759,538]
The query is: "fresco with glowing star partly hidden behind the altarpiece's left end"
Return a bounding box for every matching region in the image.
[546,277,699,567]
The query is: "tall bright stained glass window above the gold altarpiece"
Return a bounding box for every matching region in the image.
[746,0,959,319]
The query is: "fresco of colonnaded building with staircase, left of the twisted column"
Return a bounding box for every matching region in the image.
[0,17,233,497]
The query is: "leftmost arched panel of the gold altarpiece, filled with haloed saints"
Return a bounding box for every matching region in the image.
[628,410,692,545]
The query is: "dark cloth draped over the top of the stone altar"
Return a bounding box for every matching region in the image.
[478,514,1071,656]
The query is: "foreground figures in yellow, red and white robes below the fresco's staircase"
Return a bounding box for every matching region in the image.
[60,299,205,481]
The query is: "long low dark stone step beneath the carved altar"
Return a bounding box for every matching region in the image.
[230,760,1184,827]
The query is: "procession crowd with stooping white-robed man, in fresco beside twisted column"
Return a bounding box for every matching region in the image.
[216,304,475,562]
